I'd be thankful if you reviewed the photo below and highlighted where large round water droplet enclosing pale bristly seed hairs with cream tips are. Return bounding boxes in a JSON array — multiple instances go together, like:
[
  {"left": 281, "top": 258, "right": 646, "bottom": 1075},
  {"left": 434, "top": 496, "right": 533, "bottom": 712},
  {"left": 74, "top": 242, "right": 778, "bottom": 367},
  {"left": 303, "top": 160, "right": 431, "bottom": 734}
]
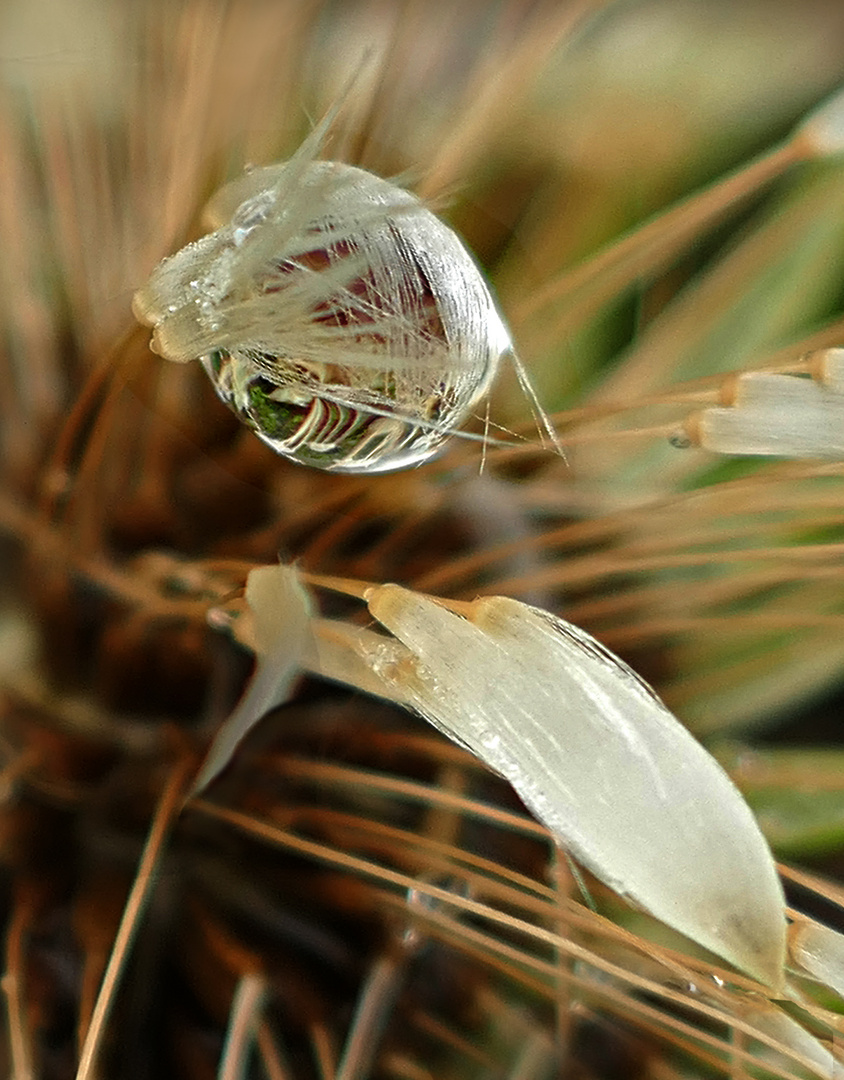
[{"left": 134, "top": 158, "right": 511, "bottom": 472}]
